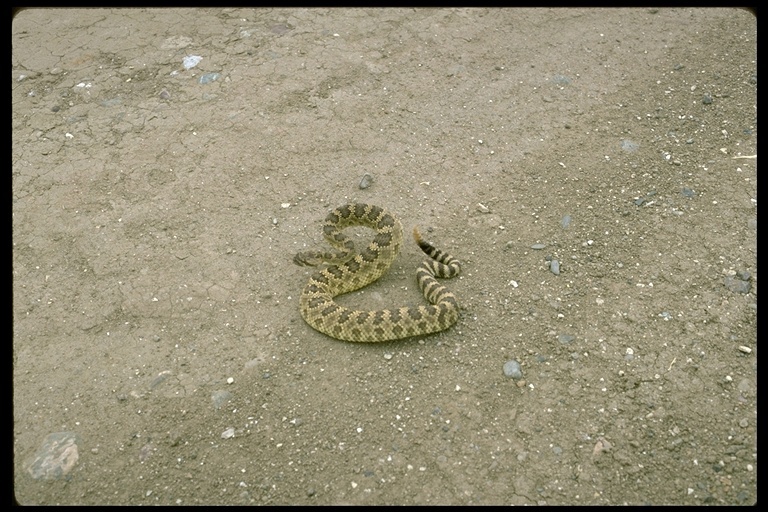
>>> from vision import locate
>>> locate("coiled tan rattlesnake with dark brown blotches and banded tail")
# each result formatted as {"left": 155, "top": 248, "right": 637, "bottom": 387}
{"left": 293, "top": 203, "right": 461, "bottom": 342}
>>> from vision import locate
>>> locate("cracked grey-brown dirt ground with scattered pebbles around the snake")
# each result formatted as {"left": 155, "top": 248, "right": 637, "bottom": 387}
{"left": 12, "top": 9, "right": 757, "bottom": 505}
